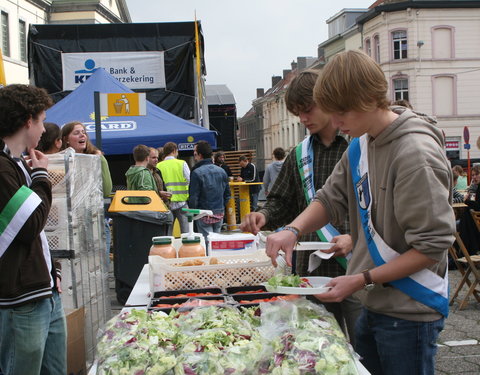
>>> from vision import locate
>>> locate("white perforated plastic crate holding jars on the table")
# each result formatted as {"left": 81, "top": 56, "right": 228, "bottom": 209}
{"left": 149, "top": 250, "right": 275, "bottom": 293}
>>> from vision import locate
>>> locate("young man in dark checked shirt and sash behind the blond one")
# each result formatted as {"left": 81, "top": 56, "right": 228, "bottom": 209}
{"left": 241, "top": 70, "right": 361, "bottom": 343}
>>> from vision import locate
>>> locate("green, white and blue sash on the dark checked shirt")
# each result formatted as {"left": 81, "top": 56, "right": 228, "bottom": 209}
{"left": 295, "top": 136, "right": 347, "bottom": 269}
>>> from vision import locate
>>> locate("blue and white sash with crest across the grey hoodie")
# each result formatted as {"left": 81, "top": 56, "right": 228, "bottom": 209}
{"left": 348, "top": 135, "right": 448, "bottom": 317}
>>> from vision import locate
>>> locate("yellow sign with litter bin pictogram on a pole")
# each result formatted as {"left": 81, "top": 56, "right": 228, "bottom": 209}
{"left": 100, "top": 92, "right": 147, "bottom": 117}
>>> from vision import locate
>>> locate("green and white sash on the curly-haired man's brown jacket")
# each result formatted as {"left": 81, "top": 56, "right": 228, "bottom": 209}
{"left": 0, "top": 185, "right": 42, "bottom": 258}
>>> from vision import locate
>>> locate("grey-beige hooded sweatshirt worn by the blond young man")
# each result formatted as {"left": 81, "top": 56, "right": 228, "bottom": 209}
{"left": 315, "top": 107, "right": 455, "bottom": 321}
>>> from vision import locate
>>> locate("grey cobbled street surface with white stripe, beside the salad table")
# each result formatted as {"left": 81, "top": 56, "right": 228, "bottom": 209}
{"left": 110, "top": 271, "right": 480, "bottom": 375}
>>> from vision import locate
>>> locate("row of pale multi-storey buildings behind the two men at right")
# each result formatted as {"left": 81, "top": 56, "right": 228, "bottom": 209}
{"left": 240, "top": 0, "right": 480, "bottom": 168}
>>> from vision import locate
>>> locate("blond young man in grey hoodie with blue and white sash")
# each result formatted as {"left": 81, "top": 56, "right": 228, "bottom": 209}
{"left": 267, "top": 51, "right": 455, "bottom": 375}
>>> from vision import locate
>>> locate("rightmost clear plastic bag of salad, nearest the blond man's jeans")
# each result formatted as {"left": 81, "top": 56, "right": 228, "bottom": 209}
{"left": 259, "top": 298, "right": 358, "bottom": 375}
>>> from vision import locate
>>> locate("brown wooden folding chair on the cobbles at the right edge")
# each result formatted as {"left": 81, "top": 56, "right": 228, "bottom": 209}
{"left": 448, "top": 232, "right": 480, "bottom": 310}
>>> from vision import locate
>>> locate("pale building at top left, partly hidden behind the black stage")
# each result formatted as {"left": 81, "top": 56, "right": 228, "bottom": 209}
{"left": 0, "top": 0, "right": 131, "bottom": 84}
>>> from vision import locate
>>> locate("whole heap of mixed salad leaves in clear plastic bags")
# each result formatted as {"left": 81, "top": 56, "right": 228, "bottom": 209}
{"left": 97, "top": 298, "right": 357, "bottom": 375}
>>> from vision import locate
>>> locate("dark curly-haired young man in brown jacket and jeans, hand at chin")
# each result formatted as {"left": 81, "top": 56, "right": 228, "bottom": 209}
{"left": 0, "top": 85, "right": 67, "bottom": 375}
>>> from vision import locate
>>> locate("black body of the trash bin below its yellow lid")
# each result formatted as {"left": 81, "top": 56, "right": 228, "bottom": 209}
{"left": 109, "top": 211, "right": 173, "bottom": 305}
